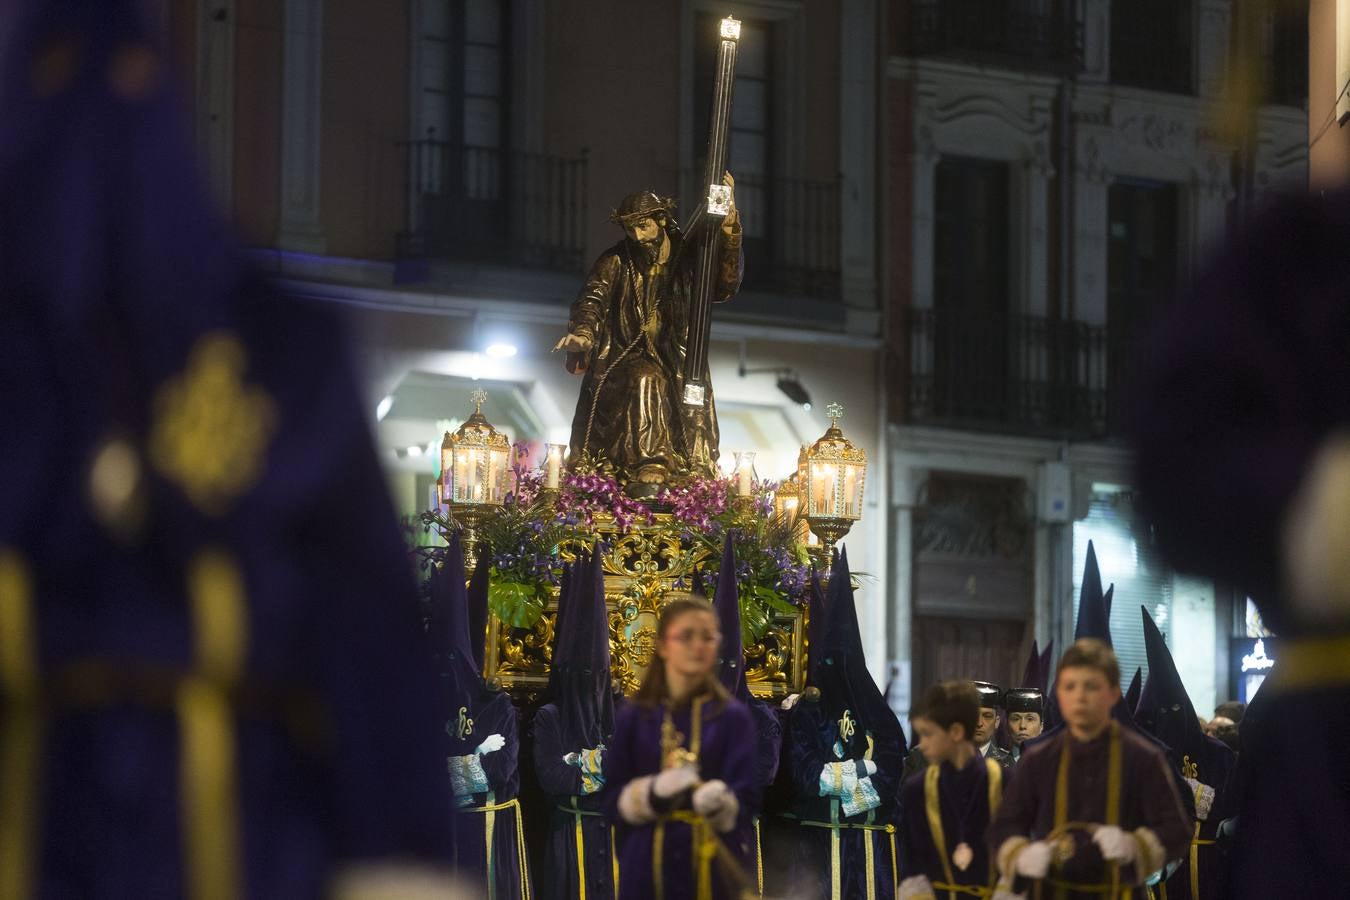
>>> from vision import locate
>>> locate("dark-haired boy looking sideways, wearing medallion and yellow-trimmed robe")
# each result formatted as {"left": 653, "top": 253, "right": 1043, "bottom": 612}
{"left": 899, "top": 681, "right": 1004, "bottom": 900}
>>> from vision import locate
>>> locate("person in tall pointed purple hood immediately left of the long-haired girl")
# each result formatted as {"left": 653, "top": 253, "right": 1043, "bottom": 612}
{"left": 535, "top": 548, "right": 617, "bottom": 900}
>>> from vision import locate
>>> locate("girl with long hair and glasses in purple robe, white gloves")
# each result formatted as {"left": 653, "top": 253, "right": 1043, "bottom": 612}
{"left": 606, "top": 596, "right": 760, "bottom": 900}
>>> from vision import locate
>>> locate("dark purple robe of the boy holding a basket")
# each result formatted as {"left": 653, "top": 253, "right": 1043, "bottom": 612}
{"left": 988, "top": 725, "right": 1192, "bottom": 899}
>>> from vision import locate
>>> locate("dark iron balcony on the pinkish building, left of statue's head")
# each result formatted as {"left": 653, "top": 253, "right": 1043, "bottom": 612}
{"left": 396, "top": 136, "right": 586, "bottom": 273}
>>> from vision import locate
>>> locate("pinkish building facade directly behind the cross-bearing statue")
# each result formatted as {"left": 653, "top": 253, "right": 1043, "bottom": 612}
{"left": 149, "top": 0, "right": 890, "bottom": 675}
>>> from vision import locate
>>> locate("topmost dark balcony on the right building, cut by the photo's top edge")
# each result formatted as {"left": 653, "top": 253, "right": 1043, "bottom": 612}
{"left": 895, "top": 0, "right": 1083, "bottom": 72}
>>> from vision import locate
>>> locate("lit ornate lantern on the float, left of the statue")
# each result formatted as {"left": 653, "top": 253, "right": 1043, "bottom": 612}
{"left": 440, "top": 390, "right": 510, "bottom": 564}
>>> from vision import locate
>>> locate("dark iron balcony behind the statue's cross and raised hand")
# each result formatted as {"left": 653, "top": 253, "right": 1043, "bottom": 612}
{"left": 680, "top": 170, "right": 840, "bottom": 301}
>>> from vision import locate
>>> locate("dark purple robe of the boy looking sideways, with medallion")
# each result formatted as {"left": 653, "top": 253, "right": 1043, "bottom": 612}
{"left": 899, "top": 753, "right": 1011, "bottom": 900}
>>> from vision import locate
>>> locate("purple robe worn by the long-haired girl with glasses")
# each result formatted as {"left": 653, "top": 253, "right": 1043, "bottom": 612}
{"left": 605, "top": 699, "right": 760, "bottom": 900}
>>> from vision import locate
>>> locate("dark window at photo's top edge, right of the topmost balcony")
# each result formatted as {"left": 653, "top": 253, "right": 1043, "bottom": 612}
{"left": 1111, "top": 0, "right": 1195, "bottom": 93}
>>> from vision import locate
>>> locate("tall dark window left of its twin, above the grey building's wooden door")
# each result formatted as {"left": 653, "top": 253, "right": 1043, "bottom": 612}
{"left": 933, "top": 158, "right": 1013, "bottom": 421}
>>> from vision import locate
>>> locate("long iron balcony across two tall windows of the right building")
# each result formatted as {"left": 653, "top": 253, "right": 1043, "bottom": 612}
{"left": 906, "top": 309, "right": 1114, "bottom": 439}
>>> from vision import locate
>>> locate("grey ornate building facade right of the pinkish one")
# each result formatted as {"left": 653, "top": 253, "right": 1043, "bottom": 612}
{"left": 882, "top": 0, "right": 1308, "bottom": 711}
